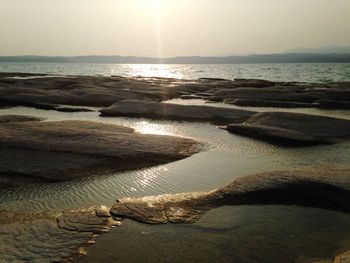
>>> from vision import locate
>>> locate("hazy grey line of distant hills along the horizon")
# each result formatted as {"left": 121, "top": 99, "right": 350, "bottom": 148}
{"left": 0, "top": 51, "right": 350, "bottom": 64}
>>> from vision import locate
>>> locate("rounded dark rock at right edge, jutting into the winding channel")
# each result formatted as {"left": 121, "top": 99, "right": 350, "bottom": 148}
{"left": 227, "top": 112, "right": 350, "bottom": 146}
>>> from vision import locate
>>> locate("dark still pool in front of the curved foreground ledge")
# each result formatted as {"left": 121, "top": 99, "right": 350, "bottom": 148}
{"left": 81, "top": 206, "right": 350, "bottom": 263}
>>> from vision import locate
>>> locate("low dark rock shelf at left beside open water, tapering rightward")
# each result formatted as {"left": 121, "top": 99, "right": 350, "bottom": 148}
{"left": 0, "top": 74, "right": 216, "bottom": 109}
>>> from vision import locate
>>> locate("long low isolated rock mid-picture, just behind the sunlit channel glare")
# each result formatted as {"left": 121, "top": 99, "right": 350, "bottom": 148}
{"left": 100, "top": 100, "right": 255, "bottom": 123}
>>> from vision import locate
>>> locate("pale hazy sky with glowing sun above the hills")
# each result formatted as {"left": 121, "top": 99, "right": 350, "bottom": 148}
{"left": 0, "top": 0, "right": 350, "bottom": 57}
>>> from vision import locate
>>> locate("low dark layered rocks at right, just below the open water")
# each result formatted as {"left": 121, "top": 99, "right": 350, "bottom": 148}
{"left": 209, "top": 80, "right": 350, "bottom": 109}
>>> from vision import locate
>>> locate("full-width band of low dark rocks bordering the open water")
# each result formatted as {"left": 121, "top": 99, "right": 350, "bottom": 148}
{"left": 0, "top": 73, "right": 350, "bottom": 110}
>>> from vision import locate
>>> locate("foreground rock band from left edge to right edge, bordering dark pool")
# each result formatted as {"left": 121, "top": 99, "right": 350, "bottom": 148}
{"left": 0, "top": 169, "right": 350, "bottom": 262}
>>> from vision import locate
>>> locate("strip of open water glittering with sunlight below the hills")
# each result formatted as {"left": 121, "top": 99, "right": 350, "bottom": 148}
{"left": 0, "top": 62, "right": 350, "bottom": 82}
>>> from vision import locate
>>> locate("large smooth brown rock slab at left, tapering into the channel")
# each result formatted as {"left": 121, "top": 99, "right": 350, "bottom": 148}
{"left": 0, "top": 118, "right": 201, "bottom": 186}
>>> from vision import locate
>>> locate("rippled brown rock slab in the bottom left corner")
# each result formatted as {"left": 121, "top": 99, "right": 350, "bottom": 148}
{"left": 0, "top": 207, "right": 120, "bottom": 262}
